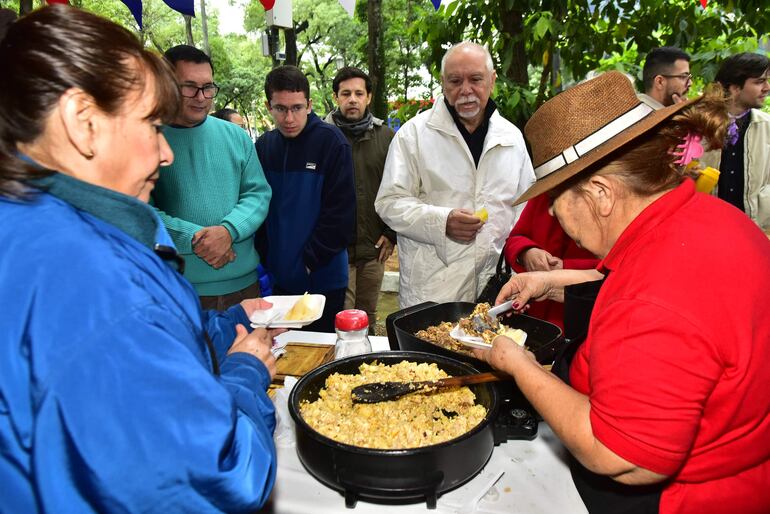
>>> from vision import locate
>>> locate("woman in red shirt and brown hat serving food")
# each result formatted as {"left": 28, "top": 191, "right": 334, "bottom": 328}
{"left": 477, "top": 72, "right": 770, "bottom": 514}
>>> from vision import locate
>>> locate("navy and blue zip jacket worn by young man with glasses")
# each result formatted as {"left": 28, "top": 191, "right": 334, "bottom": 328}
{"left": 256, "top": 112, "right": 356, "bottom": 294}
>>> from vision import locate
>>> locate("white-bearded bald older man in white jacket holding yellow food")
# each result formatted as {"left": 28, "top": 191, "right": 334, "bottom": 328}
{"left": 374, "top": 41, "right": 535, "bottom": 308}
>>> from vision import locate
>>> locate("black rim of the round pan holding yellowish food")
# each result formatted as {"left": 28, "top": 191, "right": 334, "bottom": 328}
{"left": 289, "top": 350, "right": 500, "bottom": 457}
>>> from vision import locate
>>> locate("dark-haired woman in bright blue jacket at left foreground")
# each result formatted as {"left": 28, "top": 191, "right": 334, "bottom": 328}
{"left": 0, "top": 5, "right": 282, "bottom": 512}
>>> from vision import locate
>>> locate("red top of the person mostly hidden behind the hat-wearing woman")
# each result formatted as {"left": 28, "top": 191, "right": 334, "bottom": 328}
{"left": 503, "top": 195, "right": 599, "bottom": 328}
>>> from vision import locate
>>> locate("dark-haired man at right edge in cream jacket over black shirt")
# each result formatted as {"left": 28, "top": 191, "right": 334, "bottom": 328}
{"left": 701, "top": 52, "right": 770, "bottom": 231}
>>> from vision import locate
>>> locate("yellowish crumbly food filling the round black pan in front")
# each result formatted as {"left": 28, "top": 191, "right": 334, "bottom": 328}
{"left": 300, "top": 361, "right": 487, "bottom": 449}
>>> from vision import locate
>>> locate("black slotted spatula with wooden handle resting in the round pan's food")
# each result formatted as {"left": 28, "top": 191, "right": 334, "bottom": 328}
{"left": 350, "top": 371, "right": 511, "bottom": 403}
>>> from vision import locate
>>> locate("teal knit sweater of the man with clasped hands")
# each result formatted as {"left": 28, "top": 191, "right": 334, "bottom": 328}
{"left": 152, "top": 116, "right": 271, "bottom": 296}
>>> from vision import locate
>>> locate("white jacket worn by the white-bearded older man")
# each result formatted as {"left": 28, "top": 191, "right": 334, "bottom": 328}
{"left": 374, "top": 97, "right": 535, "bottom": 308}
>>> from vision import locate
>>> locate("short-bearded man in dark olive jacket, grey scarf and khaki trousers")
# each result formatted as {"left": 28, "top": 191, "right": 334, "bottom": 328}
{"left": 325, "top": 67, "right": 396, "bottom": 334}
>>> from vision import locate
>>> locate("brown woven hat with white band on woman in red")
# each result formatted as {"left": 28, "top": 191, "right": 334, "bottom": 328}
{"left": 514, "top": 71, "right": 698, "bottom": 205}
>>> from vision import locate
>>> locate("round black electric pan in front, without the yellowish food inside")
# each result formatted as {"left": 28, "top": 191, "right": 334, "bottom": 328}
{"left": 289, "top": 352, "right": 498, "bottom": 509}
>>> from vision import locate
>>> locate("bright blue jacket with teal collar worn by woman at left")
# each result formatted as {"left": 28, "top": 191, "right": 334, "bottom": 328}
{"left": 0, "top": 175, "right": 276, "bottom": 513}
